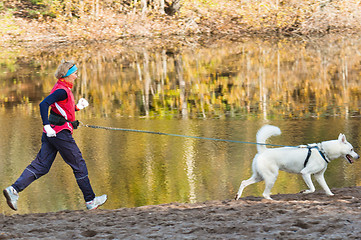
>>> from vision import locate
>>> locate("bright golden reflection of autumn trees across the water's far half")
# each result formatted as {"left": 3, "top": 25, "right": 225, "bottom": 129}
{"left": 0, "top": 37, "right": 361, "bottom": 119}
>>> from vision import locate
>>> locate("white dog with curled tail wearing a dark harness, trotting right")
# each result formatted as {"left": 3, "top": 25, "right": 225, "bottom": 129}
{"left": 236, "top": 125, "right": 359, "bottom": 200}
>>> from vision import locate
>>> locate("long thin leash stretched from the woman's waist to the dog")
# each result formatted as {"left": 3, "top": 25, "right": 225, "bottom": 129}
{"left": 80, "top": 122, "right": 299, "bottom": 147}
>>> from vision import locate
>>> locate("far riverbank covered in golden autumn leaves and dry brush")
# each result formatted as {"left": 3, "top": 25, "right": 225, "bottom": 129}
{"left": 0, "top": 0, "right": 361, "bottom": 48}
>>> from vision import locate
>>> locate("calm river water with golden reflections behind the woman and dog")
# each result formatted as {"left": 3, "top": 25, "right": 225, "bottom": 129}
{"left": 0, "top": 36, "right": 361, "bottom": 214}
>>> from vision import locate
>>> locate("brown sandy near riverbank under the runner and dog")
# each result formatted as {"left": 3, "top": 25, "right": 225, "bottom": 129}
{"left": 0, "top": 187, "right": 361, "bottom": 239}
